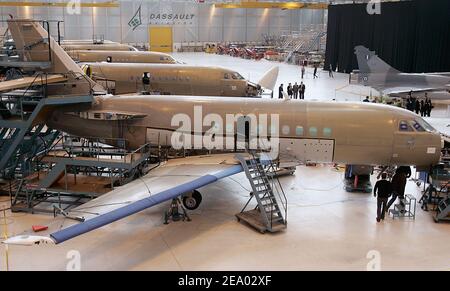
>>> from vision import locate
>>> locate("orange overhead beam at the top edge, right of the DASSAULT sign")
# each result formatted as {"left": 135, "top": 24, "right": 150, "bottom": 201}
{"left": 214, "top": 1, "right": 328, "bottom": 10}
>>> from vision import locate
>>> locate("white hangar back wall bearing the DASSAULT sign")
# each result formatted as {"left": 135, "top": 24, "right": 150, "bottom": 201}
{"left": 0, "top": 0, "right": 326, "bottom": 43}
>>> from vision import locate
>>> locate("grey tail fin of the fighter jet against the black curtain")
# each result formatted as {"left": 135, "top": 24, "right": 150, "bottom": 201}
{"left": 355, "top": 45, "right": 399, "bottom": 74}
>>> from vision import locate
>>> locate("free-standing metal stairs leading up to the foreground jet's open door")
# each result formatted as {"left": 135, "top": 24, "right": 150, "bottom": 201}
{"left": 236, "top": 152, "right": 287, "bottom": 233}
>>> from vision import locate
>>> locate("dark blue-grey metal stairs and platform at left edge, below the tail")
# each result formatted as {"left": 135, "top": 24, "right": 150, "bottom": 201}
{"left": 0, "top": 75, "right": 93, "bottom": 179}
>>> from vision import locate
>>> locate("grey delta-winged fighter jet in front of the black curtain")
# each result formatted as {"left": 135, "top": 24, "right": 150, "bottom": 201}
{"left": 355, "top": 46, "right": 450, "bottom": 98}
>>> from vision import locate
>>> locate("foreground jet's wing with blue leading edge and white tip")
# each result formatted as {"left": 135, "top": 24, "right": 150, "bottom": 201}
{"left": 3, "top": 154, "right": 242, "bottom": 246}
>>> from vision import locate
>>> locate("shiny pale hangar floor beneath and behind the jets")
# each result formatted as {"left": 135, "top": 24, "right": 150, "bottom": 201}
{"left": 0, "top": 54, "right": 450, "bottom": 270}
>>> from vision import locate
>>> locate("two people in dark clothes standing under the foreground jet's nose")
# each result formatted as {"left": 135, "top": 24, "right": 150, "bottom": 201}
{"left": 373, "top": 167, "right": 411, "bottom": 222}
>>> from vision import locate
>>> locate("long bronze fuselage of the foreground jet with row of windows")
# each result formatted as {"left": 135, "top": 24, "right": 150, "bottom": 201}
{"left": 49, "top": 96, "right": 441, "bottom": 167}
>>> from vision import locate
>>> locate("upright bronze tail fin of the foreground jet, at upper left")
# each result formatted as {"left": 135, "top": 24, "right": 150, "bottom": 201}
{"left": 8, "top": 19, "right": 102, "bottom": 91}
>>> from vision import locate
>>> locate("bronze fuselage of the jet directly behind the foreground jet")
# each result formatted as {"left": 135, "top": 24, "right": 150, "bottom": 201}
{"left": 83, "top": 63, "right": 261, "bottom": 97}
